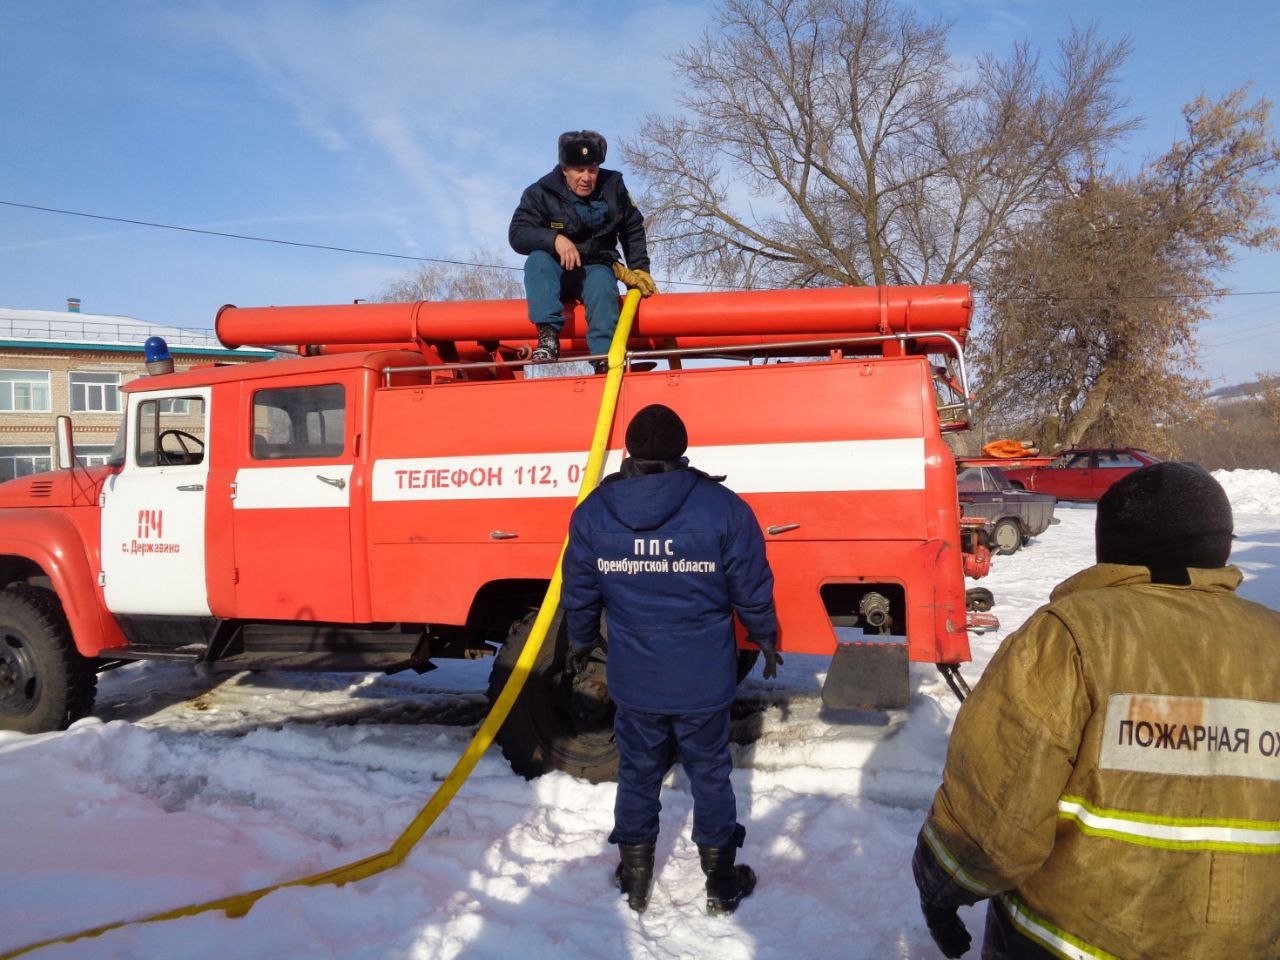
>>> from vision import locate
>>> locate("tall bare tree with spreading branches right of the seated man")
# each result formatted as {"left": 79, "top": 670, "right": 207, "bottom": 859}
{"left": 623, "top": 0, "right": 1133, "bottom": 287}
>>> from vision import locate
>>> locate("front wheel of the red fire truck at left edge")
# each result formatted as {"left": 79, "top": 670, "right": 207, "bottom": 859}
{"left": 0, "top": 586, "right": 97, "bottom": 733}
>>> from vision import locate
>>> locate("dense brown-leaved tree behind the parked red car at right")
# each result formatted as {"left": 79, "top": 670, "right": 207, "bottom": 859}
{"left": 977, "top": 90, "right": 1280, "bottom": 452}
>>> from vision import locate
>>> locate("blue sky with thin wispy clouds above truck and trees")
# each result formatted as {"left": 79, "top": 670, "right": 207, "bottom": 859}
{"left": 0, "top": 0, "right": 1280, "bottom": 383}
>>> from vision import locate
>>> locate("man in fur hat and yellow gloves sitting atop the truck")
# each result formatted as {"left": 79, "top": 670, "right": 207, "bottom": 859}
{"left": 507, "top": 131, "right": 658, "bottom": 372}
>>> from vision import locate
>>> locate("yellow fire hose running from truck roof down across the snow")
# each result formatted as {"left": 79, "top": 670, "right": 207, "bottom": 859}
{"left": 0, "top": 291, "right": 640, "bottom": 960}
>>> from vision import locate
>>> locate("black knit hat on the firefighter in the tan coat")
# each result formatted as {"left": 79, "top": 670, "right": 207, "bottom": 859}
{"left": 1094, "top": 461, "right": 1231, "bottom": 582}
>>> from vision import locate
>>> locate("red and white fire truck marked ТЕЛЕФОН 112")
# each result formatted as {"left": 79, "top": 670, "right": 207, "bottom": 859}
{"left": 0, "top": 287, "right": 970, "bottom": 777}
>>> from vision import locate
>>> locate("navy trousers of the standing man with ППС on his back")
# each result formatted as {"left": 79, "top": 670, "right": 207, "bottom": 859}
{"left": 609, "top": 707, "right": 745, "bottom": 847}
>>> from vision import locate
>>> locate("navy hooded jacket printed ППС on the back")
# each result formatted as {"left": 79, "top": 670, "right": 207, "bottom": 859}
{"left": 562, "top": 468, "right": 778, "bottom": 714}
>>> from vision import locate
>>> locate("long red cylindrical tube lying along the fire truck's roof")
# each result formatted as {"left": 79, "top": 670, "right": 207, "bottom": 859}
{"left": 215, "top": 284, "right": 973, "bottom": 347}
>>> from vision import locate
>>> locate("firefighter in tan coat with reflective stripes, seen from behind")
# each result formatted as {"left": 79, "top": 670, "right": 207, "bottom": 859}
{"left": 911, "top": 462, "right": 1280, "bottom": 960}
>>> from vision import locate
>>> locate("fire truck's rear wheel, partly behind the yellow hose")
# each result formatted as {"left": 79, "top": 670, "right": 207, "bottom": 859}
{"left": 489, "top": 611, "right": 618, "bottom": 783}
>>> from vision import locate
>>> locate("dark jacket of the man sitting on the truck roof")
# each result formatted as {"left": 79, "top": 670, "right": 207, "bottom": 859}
{"left": 507, "top": 166, "right": 649, "bottom": 270}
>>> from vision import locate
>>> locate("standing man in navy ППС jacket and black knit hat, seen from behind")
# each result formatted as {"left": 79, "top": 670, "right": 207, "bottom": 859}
{"left": 562, "top": 403, "right": 782, "bottom": 914}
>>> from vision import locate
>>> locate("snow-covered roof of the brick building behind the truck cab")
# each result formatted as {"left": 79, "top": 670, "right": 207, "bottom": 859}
{"left": 0, "top": 307, "right": 275, "bottom": 358}
